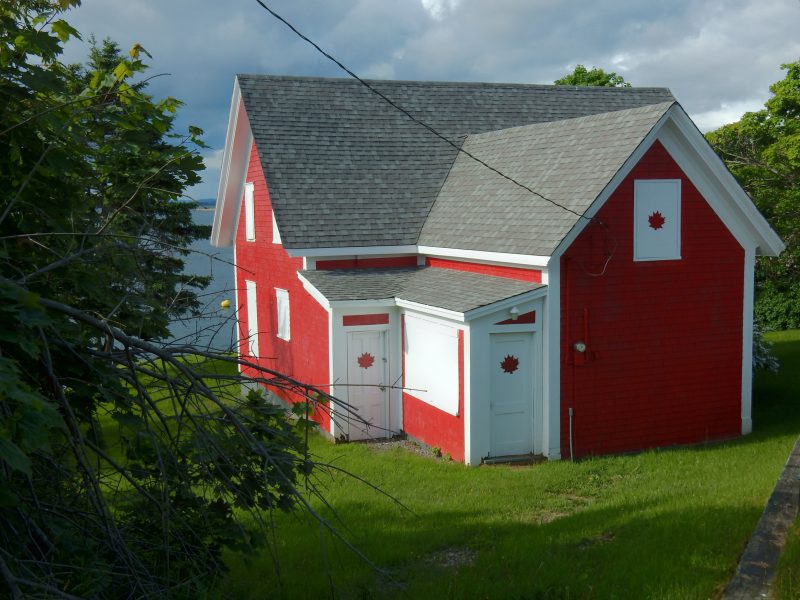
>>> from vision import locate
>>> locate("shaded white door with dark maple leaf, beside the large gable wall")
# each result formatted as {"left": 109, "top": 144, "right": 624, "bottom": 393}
{"left": 490, "top": 333, "right": 533, "bottom": 456}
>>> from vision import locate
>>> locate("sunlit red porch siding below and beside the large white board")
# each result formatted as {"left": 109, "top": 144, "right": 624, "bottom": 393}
{"left": 401, "top": 318, "right": 464, "bottom": 462}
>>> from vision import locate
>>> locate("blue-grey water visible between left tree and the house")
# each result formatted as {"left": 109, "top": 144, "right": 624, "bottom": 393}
{"left": 170, "top": 209, "right": 236, "bottom": 351}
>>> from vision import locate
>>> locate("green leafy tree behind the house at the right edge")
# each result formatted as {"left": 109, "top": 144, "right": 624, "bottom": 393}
{"left": 706, "top": 61, "right": 800, "bottom": 329}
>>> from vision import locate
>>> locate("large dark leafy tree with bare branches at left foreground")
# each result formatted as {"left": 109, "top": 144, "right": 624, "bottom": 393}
{"left": 0, "top": 0, "right": 366, "bottom": 598}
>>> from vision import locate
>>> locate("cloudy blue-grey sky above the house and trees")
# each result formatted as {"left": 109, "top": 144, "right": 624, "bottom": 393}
{"left": 61, "top": 0, "right": 800, "bottom": 198}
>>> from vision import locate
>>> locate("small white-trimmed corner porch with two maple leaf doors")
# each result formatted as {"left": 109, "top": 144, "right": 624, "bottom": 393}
{"left": 298, "top": 267, "right": 547, "bottom": 464}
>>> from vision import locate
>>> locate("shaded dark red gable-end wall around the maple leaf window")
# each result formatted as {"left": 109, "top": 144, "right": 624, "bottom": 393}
{"left": 561, "top": 142, "right": 744, "bottom": 456}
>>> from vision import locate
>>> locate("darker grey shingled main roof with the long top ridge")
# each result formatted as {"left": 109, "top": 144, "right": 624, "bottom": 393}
{"left": 238, "top": 75, "right": 673, "bottom": 249}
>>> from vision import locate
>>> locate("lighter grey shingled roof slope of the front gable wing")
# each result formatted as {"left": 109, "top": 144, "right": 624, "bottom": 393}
{"left": 419, "top": 102, "right": 673, "bottom": 256}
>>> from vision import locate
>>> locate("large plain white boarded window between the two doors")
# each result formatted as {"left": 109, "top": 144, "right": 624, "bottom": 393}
{"left": 403, "top": 314, "right": 458, "bottom": 415}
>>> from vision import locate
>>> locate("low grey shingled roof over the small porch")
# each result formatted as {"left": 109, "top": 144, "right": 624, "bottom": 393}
{"left": 300, "top": 267, "right": 545, "bottom": 313}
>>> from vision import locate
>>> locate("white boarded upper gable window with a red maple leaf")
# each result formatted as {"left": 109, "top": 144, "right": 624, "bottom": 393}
{"left": 633, "top": 179, "right": 681, "bottom": 261}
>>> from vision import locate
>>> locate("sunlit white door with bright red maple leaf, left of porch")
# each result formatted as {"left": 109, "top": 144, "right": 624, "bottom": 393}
{"left": 340, "top": 331, "right": 389, "bottom": 440}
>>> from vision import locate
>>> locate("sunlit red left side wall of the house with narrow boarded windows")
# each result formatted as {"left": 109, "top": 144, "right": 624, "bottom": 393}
{"left": 235, "top": 144, "right": 330, "bottom": 431}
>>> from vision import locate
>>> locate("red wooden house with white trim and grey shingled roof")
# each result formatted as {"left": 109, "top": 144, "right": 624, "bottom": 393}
{"left": 212, "top": 75, "right": 783, "bottom": 465}
